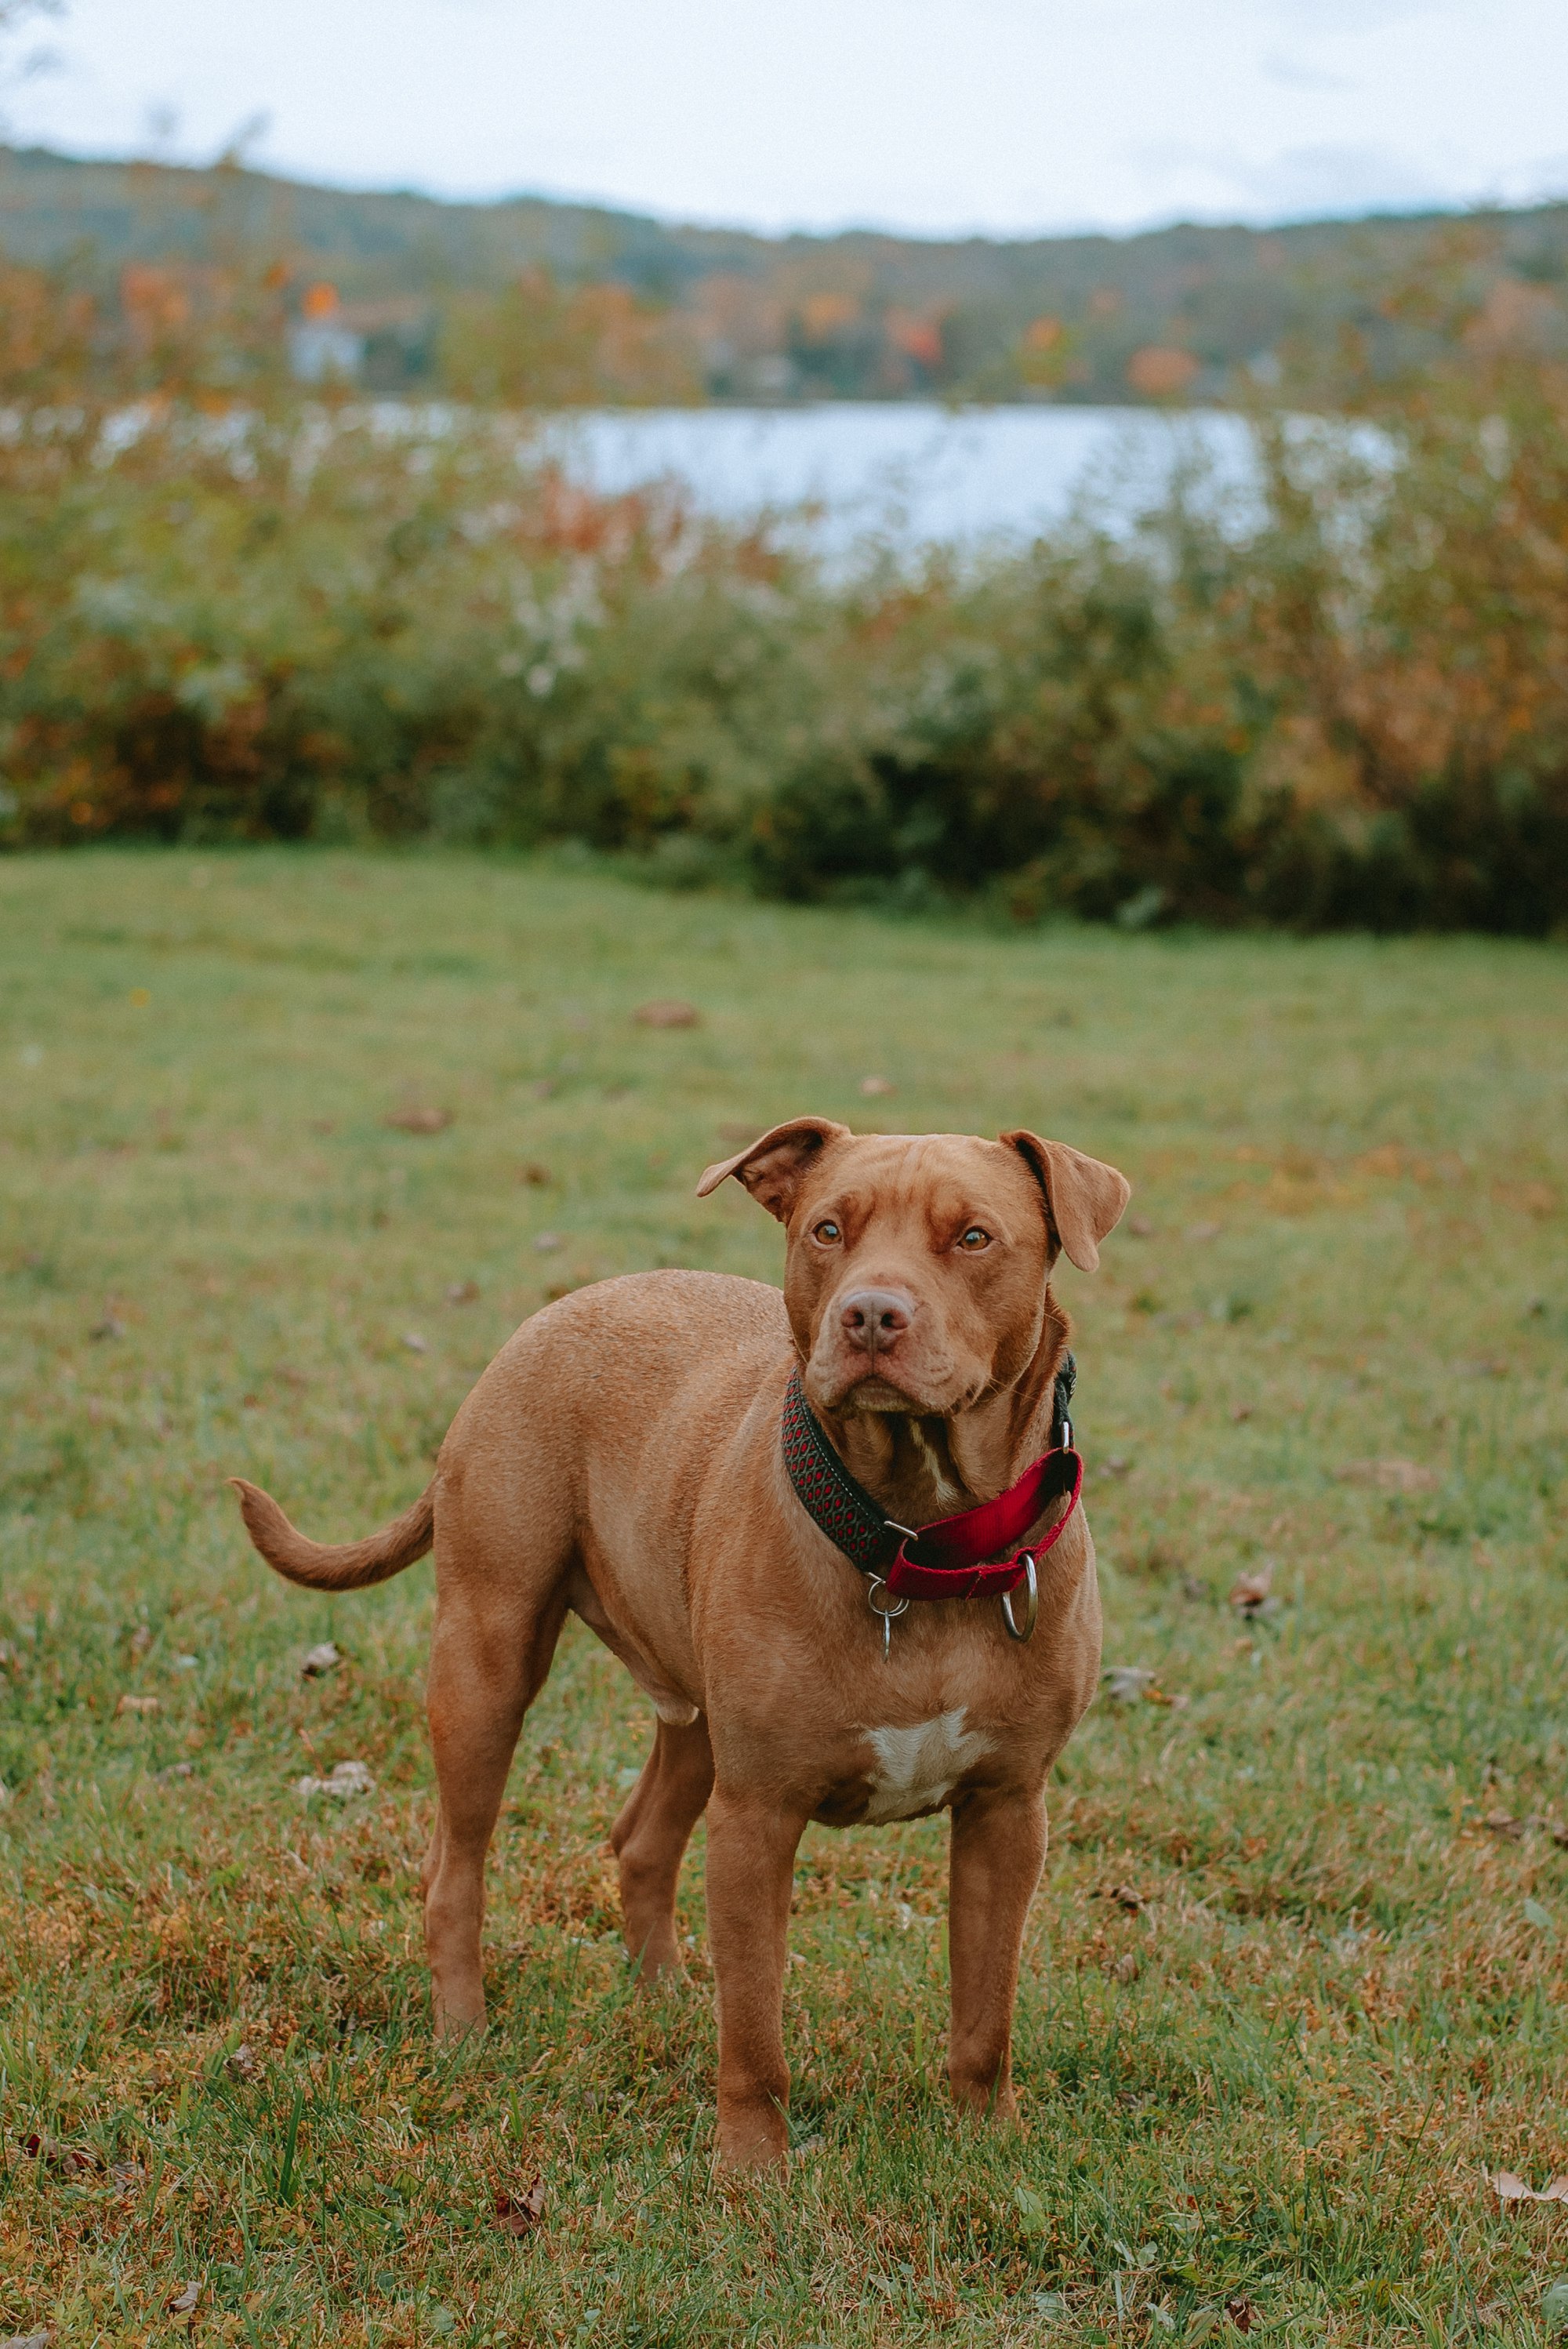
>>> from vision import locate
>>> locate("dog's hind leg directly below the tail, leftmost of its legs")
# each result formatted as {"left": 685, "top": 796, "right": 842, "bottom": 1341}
{"left": 423, "top": 1583, "right": 566, "bottom": 2039}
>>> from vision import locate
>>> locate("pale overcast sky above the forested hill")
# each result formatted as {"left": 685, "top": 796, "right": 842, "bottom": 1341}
{"left": 5, "top": 0, "right": 1568, "bottom": 233}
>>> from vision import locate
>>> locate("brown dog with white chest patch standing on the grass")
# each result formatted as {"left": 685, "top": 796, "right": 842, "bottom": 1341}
{"left": 234, "top": 1118, "right": 1129, "bottom": 2163}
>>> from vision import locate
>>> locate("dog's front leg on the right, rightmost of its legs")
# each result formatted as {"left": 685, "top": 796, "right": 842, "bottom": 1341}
{"left": 949, "top": 1792, "right": 1044, "bottom": 2116}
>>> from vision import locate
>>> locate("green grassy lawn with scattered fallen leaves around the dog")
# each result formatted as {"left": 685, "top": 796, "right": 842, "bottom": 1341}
{"left": 0, "top": 851, "right": 1568, "bottom": 2349}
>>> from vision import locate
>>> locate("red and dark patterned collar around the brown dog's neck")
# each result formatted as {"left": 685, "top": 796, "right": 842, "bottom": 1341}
{"left": 784, "top": 1370, "right": 1084, "bottom": 1611}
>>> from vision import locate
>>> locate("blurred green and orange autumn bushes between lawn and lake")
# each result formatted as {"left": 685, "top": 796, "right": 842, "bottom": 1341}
{"left": 0, "top": 248, "right": 1568, "bottom": 932}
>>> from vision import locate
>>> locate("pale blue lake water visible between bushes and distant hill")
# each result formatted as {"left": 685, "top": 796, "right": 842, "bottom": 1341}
{"left": 545, "top": 401, "right": 1251, "bottom": 552}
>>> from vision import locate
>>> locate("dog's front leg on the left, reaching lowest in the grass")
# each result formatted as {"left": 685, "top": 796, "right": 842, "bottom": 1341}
{"left": 706, "top": 1788, "right": 805, "bottom": 2168}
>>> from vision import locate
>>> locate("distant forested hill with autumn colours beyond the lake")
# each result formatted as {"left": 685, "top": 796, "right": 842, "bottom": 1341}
{"left": 0, "top": 148, "right": 1568, "bottom": 401}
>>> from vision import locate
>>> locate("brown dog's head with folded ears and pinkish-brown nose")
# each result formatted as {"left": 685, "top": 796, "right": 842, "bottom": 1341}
{"left": 697, "top": 1118, "right": 1131, "bottom": 1419}
